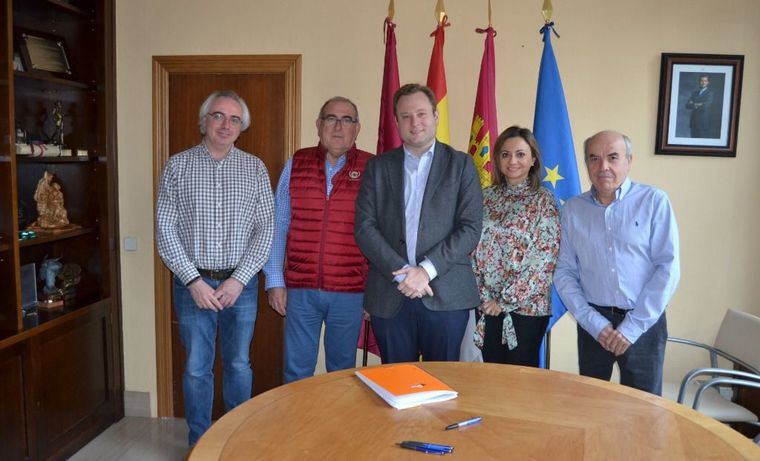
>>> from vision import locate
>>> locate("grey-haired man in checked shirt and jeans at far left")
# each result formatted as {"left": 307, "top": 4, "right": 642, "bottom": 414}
{"left": 156, "top": 91, "right": 274, "bottom": 446}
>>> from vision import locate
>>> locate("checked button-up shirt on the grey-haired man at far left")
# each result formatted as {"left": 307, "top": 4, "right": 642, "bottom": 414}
{"left": 156, "top": 143, "right": 274, "bottom": 285}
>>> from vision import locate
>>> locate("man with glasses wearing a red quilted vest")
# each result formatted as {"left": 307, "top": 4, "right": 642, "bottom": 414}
{"left": 264, "top": 96, "right": 372, "bottom": 382}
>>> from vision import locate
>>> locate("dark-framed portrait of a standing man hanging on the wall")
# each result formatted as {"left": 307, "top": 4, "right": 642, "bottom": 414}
{"left": 655, "top": 53, "right": 744, "bottom": 157}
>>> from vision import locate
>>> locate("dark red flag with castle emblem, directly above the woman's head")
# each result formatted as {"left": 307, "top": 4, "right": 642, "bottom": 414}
{"left": 469, "top": 26, "right": 499, "bottom": 187}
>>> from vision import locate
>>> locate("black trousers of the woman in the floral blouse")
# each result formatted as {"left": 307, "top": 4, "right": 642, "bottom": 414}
{"left": 476, "top": 311, "right": 550, "bottom": 368}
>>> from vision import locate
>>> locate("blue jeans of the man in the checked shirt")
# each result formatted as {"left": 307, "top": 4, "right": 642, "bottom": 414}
{"left": 173, "top": 276, "right": 259, "bottom": 446}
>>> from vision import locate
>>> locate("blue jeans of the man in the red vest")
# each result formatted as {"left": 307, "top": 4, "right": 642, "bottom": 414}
{"left": 283, "top": 288, "right": 364, "bottom": 383}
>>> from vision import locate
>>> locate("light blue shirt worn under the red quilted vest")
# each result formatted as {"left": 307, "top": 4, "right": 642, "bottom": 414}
{"left": 264, "top": 154, "right": 346, "bottom": 290}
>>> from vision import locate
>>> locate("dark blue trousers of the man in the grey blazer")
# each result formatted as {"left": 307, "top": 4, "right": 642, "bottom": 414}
{"left": 372, "top": 298, "right": 470, "bottom": 363}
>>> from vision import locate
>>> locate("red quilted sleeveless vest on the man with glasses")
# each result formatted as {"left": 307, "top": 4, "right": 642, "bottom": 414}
{"left": 285, "top": 145, "right": 372, "bottom": 293}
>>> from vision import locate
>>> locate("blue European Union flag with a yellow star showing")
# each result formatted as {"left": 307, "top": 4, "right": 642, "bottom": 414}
{"left": 533, "top": 22, "right": 581, "bottom": 368}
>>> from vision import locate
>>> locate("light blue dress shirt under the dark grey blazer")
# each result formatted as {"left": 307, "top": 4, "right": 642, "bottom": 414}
{"left": 395, "top": 140, "right": 438, "bottom": 282}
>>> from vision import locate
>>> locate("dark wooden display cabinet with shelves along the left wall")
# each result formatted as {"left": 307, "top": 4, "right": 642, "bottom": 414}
{"left": 0, "top": 0, "right": 124, "bottom": 460}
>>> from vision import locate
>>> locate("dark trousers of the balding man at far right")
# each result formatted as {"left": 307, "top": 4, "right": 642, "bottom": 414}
{"left": 578, "top": 307, "right": 668, "bottom": 395}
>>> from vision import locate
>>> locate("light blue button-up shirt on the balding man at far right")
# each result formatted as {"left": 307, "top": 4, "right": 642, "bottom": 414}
{"left": 554, "top": 178, "right": 680, "bottom": 343}
